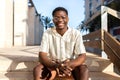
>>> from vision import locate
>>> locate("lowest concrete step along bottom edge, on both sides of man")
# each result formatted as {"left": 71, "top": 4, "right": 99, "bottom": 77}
{"left": 0, "top": 72, "right": 120, "bottom": 80}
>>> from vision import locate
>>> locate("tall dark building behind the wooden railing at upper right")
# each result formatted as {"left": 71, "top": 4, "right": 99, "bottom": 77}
{"left": 84, "top": 0, "right": 120, "bottom": 40}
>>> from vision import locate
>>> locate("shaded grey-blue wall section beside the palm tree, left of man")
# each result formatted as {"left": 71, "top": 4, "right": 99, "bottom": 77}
{"left": 27, "top": 7, "right": 43, "bottom": 45}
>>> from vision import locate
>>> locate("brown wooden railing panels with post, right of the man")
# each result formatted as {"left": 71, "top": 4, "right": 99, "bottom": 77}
{"left": 83, "top": 30, "right": 120, "bottom": 68}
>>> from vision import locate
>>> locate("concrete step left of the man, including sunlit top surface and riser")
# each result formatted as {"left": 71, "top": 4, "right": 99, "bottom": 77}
{"left": 0, "top": 46, "right": 39, "bottom": 72}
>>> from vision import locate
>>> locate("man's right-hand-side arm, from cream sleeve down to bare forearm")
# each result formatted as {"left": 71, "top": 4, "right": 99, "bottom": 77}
{"left": 66, "top": 32, "right": 86, "bottom": 68}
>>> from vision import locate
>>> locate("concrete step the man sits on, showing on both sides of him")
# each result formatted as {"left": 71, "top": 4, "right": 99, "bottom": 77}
{"left": 0, "top": 47, "right": 113, "bottom": 72}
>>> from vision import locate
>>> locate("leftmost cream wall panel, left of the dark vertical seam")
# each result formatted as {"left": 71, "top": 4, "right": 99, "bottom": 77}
{"left": 0, "top": 0, "right": 13, "bottom": 47}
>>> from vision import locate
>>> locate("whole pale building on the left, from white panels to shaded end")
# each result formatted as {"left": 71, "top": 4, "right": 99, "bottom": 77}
{"left": 0, "top": 0, "right": 43, "bottom": 48}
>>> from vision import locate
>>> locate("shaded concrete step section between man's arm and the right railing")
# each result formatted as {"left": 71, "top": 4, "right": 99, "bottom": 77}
{"left": 86, "top": 53, "right": 114, "bottom": 72}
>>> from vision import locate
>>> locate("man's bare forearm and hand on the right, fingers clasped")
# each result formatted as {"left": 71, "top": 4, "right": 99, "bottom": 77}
{"left": 55, "top": 53, "right": 86, "bottom": 76}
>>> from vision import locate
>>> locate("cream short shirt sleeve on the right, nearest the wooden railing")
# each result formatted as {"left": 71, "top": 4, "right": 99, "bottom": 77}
{"left": 74, "top": 33, "right": 86, "bottom": 56}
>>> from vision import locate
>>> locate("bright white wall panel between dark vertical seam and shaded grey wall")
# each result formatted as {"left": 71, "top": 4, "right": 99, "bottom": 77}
{"left": 14, "top": 0, "right": 28, "bottom": 46}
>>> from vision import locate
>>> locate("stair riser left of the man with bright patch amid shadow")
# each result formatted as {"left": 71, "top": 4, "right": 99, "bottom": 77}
{"left": 0, "top": 61, "right": 37, "bottom": 72}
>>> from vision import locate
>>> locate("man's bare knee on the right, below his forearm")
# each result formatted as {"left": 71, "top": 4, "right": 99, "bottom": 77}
{"left": 72, "top": 65, "right": 89, "bottom": 80}
